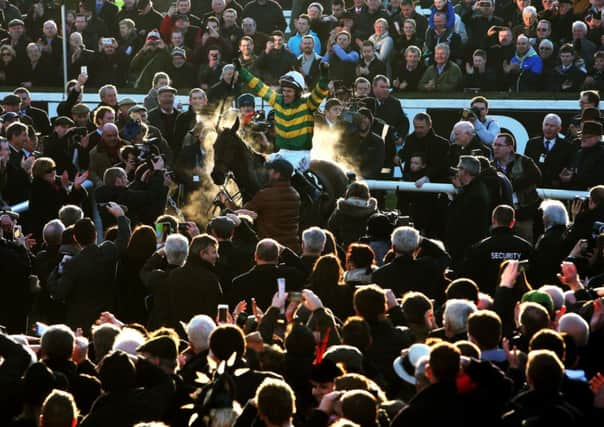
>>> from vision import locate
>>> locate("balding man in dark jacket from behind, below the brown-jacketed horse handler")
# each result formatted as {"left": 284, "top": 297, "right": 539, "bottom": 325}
{"left": 227, "top": 239, "right": 302, "bottom": 310}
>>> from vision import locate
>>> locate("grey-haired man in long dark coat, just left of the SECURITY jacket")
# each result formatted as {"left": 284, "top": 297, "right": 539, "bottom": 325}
{"left": 445, "top": 156, "right": 490, "bottom": 267}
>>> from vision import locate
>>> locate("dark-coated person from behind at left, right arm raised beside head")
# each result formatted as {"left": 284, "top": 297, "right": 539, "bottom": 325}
{"left": 49, "top": 202, "right": 130, "bottom": 330}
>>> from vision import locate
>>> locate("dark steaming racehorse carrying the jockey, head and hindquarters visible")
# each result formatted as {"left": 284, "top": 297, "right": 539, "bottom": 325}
{"left": 211, "top": 118, "right": 348, "bottom": 226}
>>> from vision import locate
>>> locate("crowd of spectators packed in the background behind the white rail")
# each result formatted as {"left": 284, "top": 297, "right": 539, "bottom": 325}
{"left": 0, "top": 0, "right": 604, "bottom": 93}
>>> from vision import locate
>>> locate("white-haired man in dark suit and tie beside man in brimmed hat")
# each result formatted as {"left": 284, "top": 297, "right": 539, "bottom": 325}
{"left": 524, "top": 113, "right": 575, "bottom": 188}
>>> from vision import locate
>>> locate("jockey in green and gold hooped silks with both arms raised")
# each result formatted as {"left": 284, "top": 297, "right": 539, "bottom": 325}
{"left": 235, "top": 61, "right": 328, "bottom": 172}
